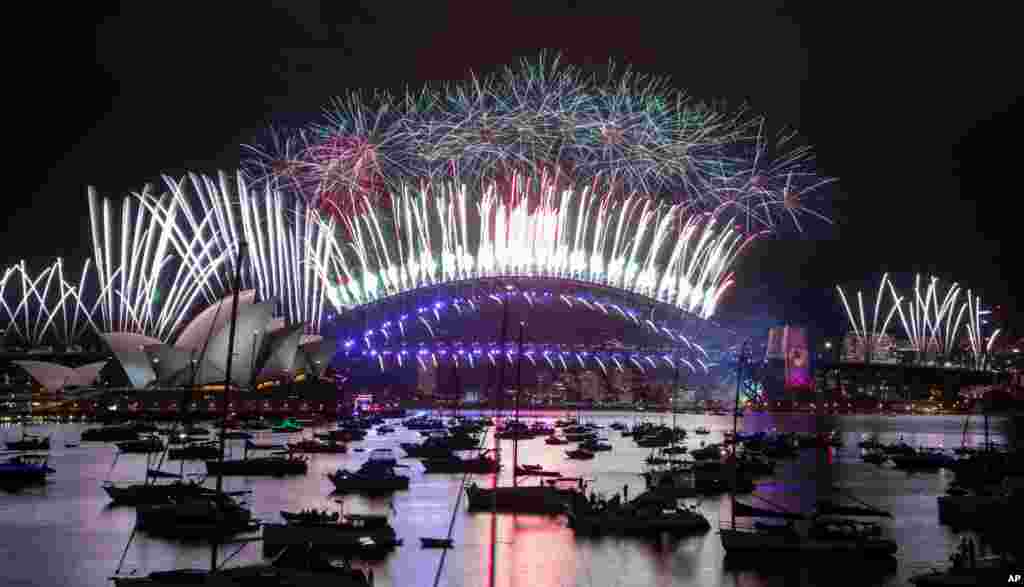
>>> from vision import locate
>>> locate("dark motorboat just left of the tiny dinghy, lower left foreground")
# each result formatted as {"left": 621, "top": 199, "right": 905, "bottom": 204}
{"left": 263, "top": 514, "right": 401, "bottom": 558}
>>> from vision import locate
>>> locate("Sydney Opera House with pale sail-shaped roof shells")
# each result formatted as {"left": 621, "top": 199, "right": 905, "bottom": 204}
{"left": 7, "top": 290, "right": 336, "bottom": 411}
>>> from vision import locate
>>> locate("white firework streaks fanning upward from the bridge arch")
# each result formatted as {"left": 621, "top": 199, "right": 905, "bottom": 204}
{"left": 327, "top": 172, "right": 762, "bottom": 322}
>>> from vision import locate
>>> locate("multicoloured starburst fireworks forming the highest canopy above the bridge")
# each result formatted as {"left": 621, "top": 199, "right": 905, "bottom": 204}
{"left": 247, "top": 56, "right": 833, "bottom": 230}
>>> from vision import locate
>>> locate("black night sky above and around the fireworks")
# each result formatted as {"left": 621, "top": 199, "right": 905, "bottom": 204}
{"left": 0, "top": 1, "right": 1024, "bottom": 338}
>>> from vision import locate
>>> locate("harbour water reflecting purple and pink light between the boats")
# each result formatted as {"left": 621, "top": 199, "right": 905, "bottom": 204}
{"left": 0, "top": 411, "right": 1017, "bottom": 587}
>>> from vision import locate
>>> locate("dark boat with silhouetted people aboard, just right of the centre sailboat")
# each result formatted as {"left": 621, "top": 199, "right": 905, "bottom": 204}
{"left": 567, "top": 493, "right": 711, "bottom": 536}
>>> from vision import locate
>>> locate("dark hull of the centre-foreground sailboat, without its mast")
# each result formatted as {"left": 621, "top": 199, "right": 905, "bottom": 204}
{"left": 466, "top": 477, "right": 586, "bottom": 513}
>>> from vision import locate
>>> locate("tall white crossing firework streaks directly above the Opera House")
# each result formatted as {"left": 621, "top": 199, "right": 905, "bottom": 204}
{"left": 90, "top": 174, "right": 340, "bottom": 340}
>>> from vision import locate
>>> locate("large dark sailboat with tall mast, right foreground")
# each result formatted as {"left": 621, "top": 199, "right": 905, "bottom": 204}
{"left": 719, "top": 344, "right": 898, "bottom": 558}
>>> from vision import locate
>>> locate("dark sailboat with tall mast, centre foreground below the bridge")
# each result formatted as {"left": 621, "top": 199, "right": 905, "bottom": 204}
{"left": 466, "top": 319, "right": 586, "bottom": 513}
